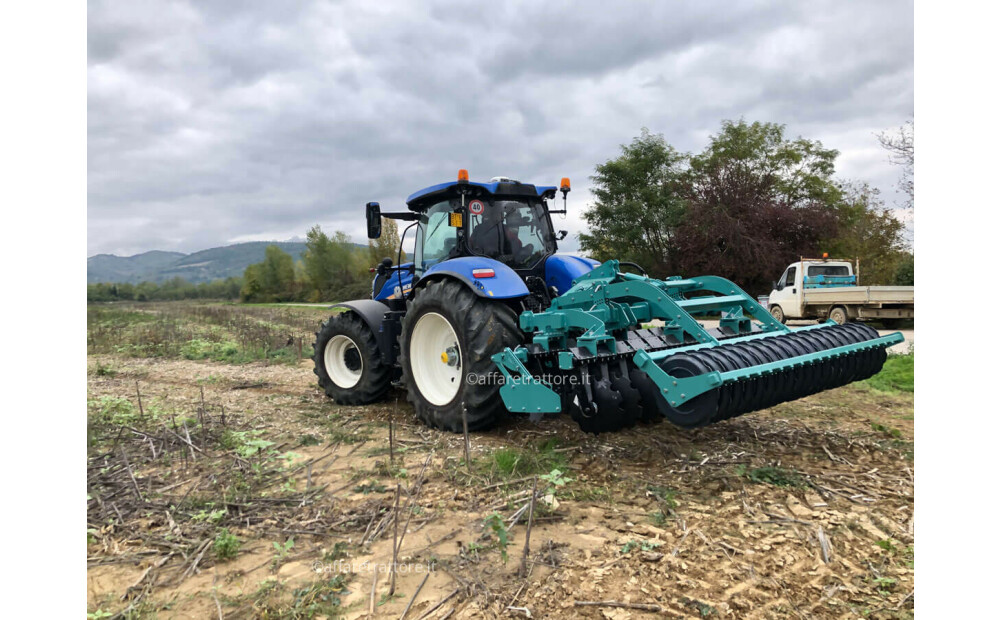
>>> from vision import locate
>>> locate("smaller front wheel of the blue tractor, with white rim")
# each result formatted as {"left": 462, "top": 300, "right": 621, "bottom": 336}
{"left": 313, "top": 312, "right": 392, "bottom": 405}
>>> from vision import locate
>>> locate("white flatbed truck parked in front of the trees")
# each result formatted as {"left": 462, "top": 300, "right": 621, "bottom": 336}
{"left": 759, "top": 258, "right": 913, "bottom": 329}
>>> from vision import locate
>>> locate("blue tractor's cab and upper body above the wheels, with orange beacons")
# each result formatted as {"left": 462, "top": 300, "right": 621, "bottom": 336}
{"left": 367, "top": 170, "right": 597, "bottom": 310}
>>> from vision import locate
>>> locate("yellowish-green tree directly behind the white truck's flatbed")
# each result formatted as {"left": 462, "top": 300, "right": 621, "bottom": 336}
{"left": 822, "top": 183, "right": 903, "bottom": 284}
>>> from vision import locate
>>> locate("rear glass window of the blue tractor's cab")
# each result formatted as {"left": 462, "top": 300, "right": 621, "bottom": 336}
{"left": 469, "top": 200, "right": 555, "bottom": 269}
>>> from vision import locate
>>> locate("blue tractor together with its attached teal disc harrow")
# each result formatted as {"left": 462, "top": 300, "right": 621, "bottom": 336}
{"left": 314, "top": 170, "right": 902, "bottom": 433}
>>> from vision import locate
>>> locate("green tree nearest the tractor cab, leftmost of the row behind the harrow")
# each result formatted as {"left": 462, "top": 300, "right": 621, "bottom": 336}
{"left": 580, "top": 128, "right": 686, "bottom": 276}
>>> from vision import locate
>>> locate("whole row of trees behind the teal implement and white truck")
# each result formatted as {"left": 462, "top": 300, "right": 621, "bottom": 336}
{"left": 580, "top": 120, "right": 913, "bottom": 294}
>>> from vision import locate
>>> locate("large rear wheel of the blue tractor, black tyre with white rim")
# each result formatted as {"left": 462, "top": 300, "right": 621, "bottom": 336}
{"left": 399, "top": 280, "right": 523, "bottom": 433}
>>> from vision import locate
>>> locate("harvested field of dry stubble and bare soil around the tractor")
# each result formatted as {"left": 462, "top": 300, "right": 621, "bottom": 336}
{"left": 87, "top": 302, "right": 914, "bottom": 619}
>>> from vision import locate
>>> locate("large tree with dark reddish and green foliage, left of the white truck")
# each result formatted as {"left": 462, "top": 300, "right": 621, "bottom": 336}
{"left": 672, "top": 119, "right": 842, "bottom": 293}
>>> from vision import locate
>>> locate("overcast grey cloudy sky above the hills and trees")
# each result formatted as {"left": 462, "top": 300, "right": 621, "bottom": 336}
{"left": 87, "top": 0, "right": 913, "bottom": 255}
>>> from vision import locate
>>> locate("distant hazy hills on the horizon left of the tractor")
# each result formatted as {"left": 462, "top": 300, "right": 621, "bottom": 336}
{"left": 87, "top": 241, "right": 312, "bottom": 284}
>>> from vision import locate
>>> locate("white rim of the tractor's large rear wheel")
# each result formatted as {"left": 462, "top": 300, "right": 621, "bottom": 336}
{"left": 409, "top": 312, "right": 462, "bottom": 407}
